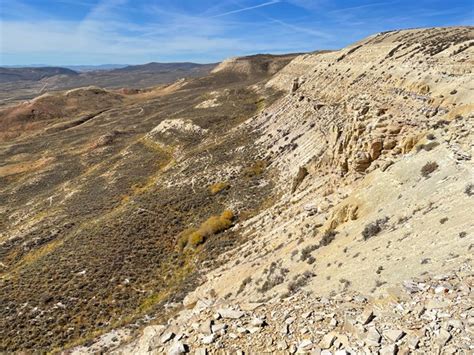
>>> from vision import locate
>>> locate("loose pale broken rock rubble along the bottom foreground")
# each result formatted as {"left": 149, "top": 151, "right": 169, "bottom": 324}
{"left": 115, "top": 264, "right": 474, "bottom": 355}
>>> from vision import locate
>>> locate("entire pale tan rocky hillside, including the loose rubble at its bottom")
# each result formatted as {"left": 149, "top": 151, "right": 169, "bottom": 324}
{"left": 105, "top": 28, "right": 474, "bottom": 354}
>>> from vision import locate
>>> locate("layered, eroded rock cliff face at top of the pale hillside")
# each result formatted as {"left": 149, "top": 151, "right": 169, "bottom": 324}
{"left": 262, "top": 28, "right": 474, "bottom": 184}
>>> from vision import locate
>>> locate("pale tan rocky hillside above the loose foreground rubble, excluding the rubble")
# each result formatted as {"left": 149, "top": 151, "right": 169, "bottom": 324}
{"left": 177, "top": 23, "right": 474, "bottom": 312}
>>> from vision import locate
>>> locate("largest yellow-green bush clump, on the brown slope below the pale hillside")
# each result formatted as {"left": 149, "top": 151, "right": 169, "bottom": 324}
{"left": 178, "top": 210, "right": 234, "bottom": 250}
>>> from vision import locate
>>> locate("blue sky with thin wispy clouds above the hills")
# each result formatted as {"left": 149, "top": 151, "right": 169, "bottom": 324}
{"left": 0, "top": 0, "right": 474, "bottom": 65}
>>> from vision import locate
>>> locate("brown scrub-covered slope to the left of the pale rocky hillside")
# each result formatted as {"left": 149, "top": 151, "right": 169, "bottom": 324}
{"left": 0, "top": 54, "right": 288, "bottom": 352}
